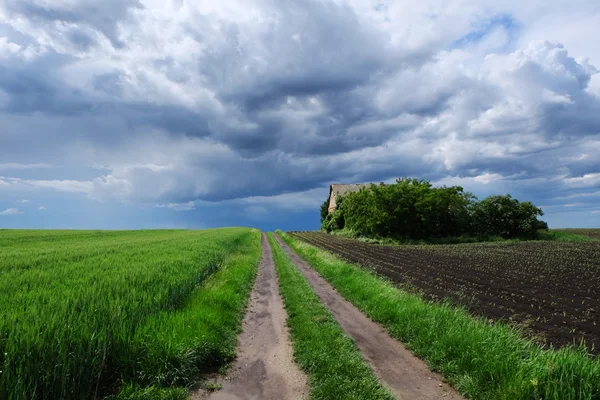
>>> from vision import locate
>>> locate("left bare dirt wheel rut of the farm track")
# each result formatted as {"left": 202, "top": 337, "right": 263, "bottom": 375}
{"left": 192, "top": 233, "right": 308, "bottom": 400}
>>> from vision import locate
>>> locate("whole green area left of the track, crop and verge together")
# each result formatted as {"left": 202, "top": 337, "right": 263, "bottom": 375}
{"left": 0, "top": 228, "right": 260, "bottom": 400}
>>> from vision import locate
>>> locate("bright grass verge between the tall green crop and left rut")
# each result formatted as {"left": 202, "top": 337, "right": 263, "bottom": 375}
{"left": 116, "top": 230, "right": 261, "bottom": 400}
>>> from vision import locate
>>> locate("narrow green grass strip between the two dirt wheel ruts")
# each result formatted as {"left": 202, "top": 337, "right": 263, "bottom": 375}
{"left": 269, "top": 234, "right": 393, "bottom": 400}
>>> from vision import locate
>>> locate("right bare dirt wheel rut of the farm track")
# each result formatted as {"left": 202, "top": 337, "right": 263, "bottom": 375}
{"left": 276, "top": 236, "right": 462, "bottom": 400}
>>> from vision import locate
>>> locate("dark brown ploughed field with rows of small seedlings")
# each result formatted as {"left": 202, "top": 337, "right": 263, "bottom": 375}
{"left": 293, "top": 230, "right": 600, "bottom": 353}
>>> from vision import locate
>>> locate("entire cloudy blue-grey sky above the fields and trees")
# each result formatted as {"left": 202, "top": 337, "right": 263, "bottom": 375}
{"left": 0, "top": 0, "right": 600, "bottom": 230}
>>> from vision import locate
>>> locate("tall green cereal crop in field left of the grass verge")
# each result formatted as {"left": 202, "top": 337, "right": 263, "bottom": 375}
{"left": 0, "top": 228, "right": 259, "bottom": 400}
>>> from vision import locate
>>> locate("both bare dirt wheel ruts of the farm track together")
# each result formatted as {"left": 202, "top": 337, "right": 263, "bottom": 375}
{"left": 192, "top": 233, "right": 463, "bottom": 400}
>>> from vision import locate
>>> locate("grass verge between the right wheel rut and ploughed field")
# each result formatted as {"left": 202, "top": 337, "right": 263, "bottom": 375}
{"left": 278, "top": 231, "right": 600, "bottom": 400}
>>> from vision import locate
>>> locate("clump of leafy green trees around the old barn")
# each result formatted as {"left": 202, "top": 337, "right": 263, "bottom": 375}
{"left": 321, "top": 178, "right": 548, "bottom": 240}
